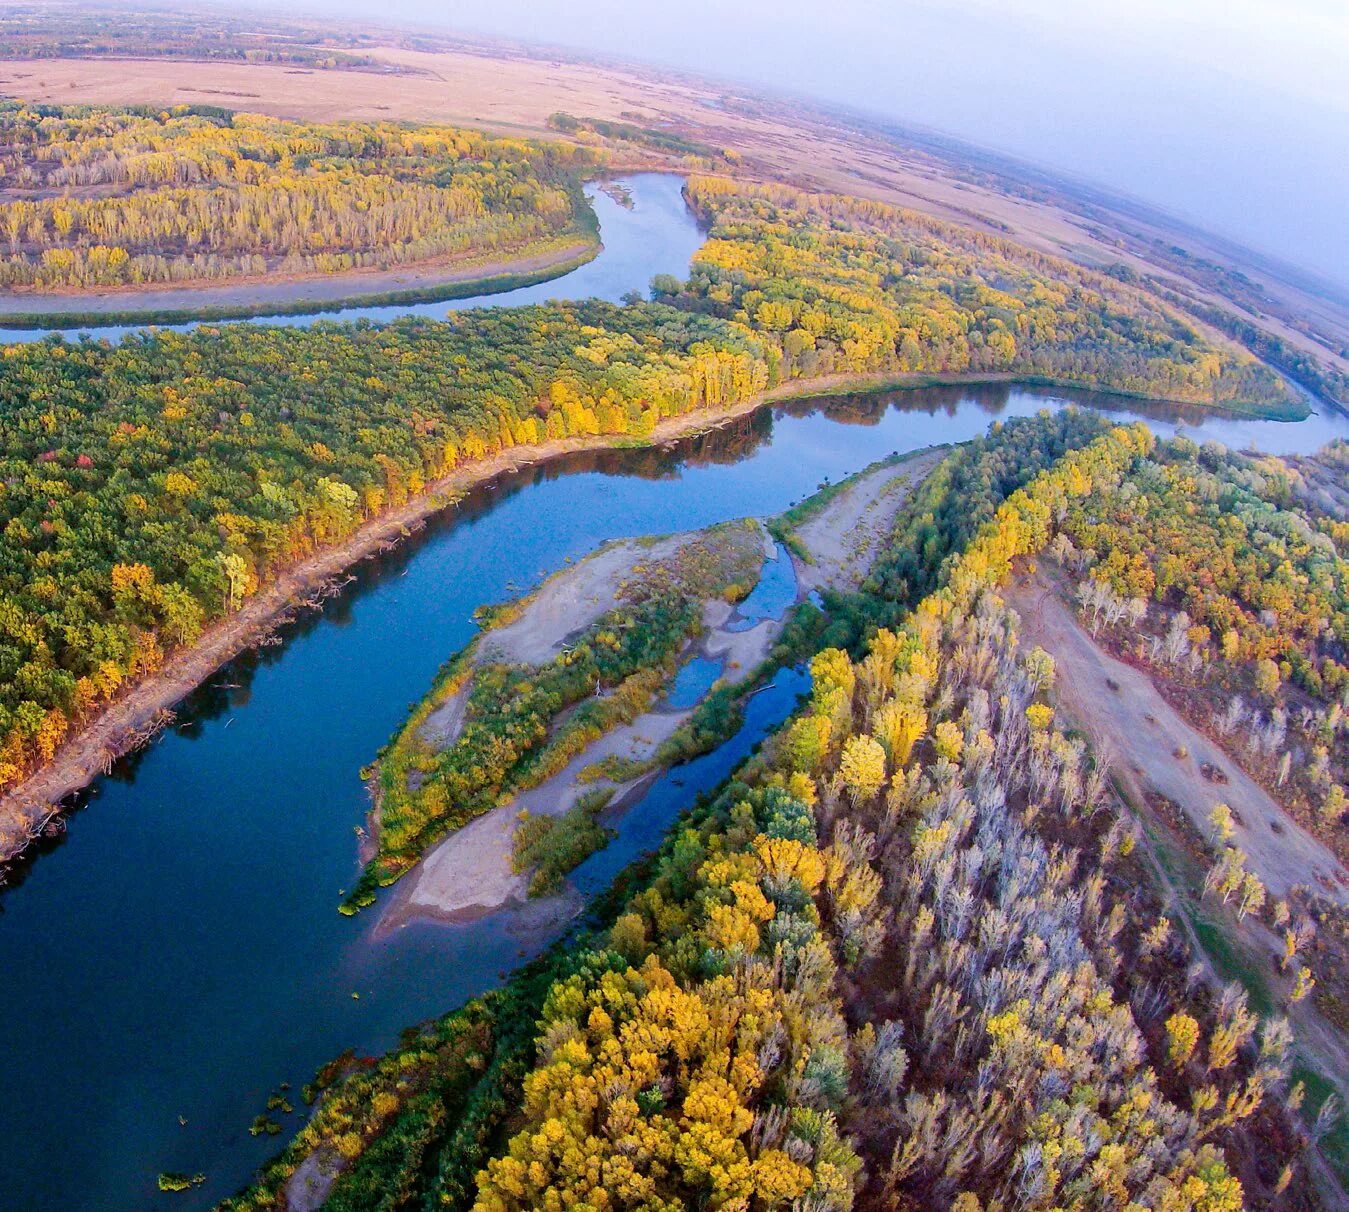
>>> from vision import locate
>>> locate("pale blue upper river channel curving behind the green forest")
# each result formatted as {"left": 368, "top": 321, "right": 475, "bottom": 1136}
{"left": 0, "top": 173, "right": 703, "bottom": 343}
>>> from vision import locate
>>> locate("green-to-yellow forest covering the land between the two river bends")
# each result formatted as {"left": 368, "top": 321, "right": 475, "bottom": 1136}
{"left": 0, "top": 165, "right": 1292, "bottom": 836}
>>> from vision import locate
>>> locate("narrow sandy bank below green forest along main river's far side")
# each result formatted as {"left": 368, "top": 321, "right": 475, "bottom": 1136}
{"left": 0, "top": 373, "right": 1311, "bottom": 869}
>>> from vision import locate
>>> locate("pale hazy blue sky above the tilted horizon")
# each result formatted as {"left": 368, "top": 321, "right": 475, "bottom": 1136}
{"left": 308, "top": 0, "right": 1349, "bottom": 285}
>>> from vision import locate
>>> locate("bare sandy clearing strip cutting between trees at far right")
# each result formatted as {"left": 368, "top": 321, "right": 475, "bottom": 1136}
{"left": 1004, "top": 572, "right": 1349, "bottom": 906}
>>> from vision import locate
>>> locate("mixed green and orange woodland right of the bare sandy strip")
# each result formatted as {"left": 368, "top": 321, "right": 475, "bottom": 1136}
{"left": 1055, "top": 439, "right": 1349, "bottom": 858}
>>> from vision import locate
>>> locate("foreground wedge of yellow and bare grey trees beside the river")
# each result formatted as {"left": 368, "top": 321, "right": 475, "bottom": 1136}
{"left": 225, "top": 414, "right": 1332, "bottom": 1212}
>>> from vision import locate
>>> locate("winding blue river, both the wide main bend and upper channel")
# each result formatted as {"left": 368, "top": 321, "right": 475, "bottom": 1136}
{"left": 0, "top": 177, "right": 1349, "bottom": 1212}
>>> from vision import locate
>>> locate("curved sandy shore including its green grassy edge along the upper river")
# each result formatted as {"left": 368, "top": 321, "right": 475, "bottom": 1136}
{"left": 0, "top": 238, "right": 604, "bottom": 332}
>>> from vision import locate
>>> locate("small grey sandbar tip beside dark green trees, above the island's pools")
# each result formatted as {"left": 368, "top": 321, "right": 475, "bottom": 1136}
{"left": 793, "top": 449, "right": 946, "bottom": 597}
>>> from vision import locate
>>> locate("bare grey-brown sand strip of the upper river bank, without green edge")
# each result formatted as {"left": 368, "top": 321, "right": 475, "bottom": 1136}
{"left": 0, "top": 240, "right": 599, "bottom": 318}
